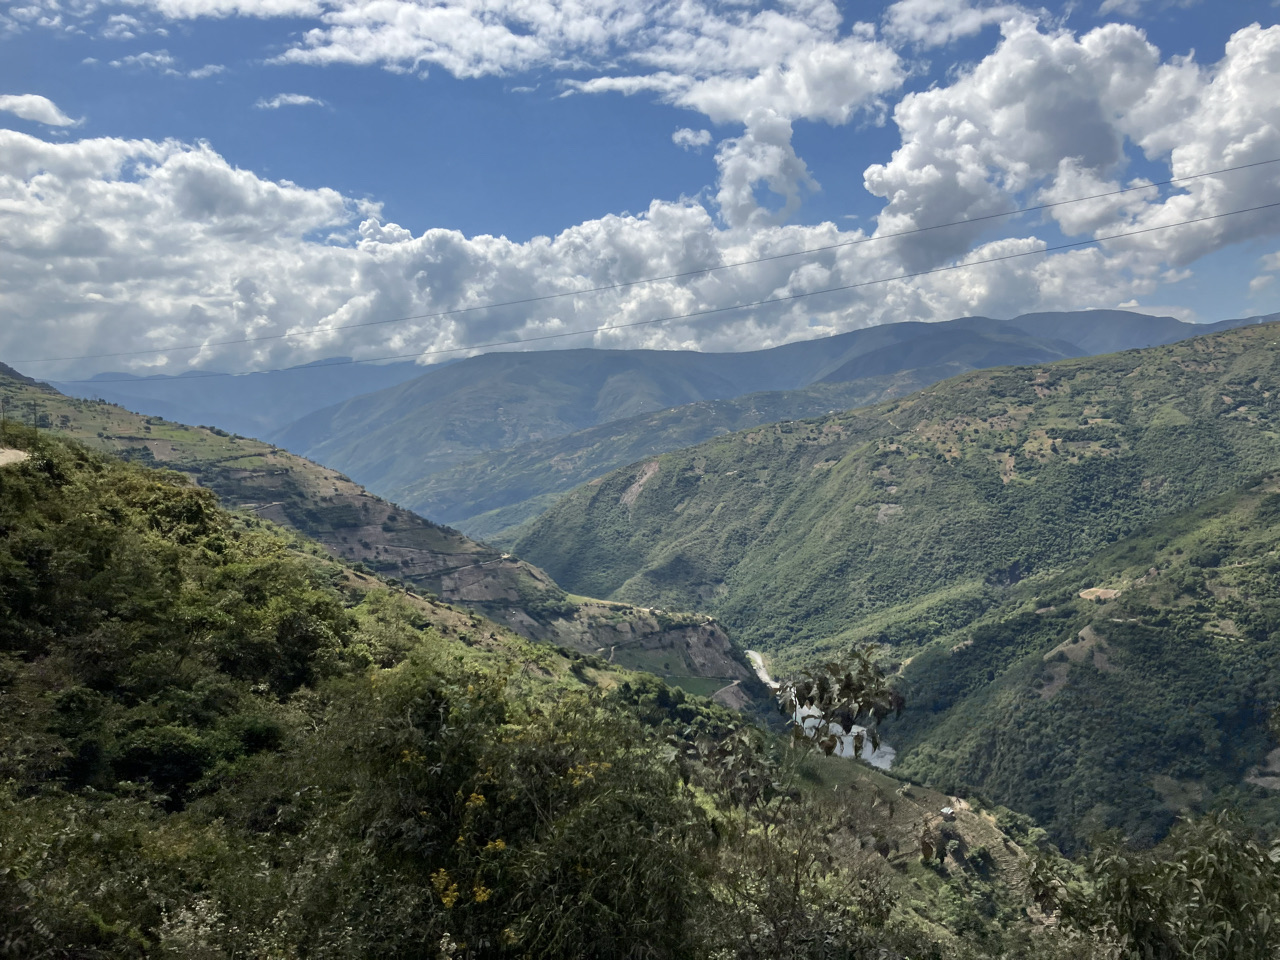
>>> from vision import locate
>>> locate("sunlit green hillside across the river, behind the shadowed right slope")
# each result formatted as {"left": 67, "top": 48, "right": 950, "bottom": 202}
{"left": 515, "top": 325, "right": 1280, "bottom": 650}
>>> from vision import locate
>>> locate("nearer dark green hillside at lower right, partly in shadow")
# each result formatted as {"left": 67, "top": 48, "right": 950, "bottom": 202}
{"left": 888, "top": 477, "right": 1280, "bottom": 845}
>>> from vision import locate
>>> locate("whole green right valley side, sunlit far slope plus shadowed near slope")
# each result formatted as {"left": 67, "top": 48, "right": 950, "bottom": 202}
{"left": 516, "top": 325, "right": 1280, "bottom": 849}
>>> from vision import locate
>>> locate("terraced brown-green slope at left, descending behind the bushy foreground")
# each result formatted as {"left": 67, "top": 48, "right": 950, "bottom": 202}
{"left": 0, "top": 365, "right": 763, "bottom": 707}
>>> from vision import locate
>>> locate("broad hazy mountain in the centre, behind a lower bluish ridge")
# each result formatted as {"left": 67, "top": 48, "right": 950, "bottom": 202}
{"left": 271, "top": 314, "right": 1162, "bottom": 497}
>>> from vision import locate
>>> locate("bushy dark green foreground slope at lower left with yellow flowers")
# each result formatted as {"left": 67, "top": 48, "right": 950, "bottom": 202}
{"left": 0, "top": 425, "right": 1095, "bottom": 960}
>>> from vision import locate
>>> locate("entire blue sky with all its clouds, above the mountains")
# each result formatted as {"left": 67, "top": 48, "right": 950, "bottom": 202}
{"left": 0, "top": 0, "right": 1280, "bottom": 378}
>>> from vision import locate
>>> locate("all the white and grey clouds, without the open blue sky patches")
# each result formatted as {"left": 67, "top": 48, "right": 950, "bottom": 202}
{"left": 0, "top": 8, "right": 1280, "bottom": 376}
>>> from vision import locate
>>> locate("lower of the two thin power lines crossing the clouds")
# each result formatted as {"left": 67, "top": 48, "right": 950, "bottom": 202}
{"left": 55, "top": 201, "right": 1280, "bottom": 384}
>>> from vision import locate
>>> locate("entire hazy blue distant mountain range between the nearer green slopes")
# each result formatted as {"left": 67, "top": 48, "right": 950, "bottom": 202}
{"left": 54, "top": 310, "right": 1258, "bottom": 540}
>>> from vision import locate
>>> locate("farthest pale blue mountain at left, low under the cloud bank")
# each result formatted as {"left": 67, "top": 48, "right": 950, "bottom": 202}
{"left": 52, "top": 357, "right": 424, "bottom": 436}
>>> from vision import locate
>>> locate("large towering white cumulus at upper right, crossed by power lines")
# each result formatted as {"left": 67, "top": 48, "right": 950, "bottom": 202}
{"left": 865, "top": 19, "right": 1280, "bottom": 274}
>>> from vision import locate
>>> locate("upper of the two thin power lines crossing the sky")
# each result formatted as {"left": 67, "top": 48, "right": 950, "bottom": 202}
{"left": 12, "top": 157, "right": 1280, "bottom": 371}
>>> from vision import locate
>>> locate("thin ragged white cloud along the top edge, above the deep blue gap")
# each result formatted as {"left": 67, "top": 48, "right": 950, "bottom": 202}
{"left": 35, "top": 0, "right": 906, "bottom": 129}
